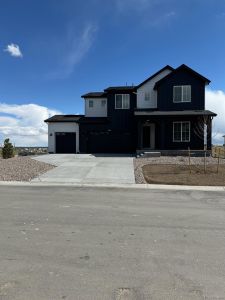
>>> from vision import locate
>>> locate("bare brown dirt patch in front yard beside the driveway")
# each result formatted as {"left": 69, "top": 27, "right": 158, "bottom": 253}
{"left": 142, "top": 164, "right": 225, "bottom": 186}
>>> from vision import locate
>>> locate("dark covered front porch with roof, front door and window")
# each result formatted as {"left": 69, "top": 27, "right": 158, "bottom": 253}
{"left": 135, "top": 110, "right": 216, "bottom": 152}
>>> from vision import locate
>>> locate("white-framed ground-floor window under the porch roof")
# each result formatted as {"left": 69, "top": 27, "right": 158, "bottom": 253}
{"left": 173, "top": 122, "right": 190, "bottom": 142}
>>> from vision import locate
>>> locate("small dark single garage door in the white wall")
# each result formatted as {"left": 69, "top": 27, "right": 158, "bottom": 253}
{"left": 55, "top": 132, "right": 76, "bottom": 153}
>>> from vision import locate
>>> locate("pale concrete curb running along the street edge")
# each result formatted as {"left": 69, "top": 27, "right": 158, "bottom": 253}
{"left": 0, "top": 181, "right": 225, "bottom": 192}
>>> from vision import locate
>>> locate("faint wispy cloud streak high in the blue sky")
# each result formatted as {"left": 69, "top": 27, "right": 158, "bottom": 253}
{"left": 47, "top": 23, "right": 98, "bottom": 79}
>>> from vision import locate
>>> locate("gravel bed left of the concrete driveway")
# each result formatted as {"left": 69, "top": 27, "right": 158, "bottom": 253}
{"left": 0, "top": 156, "right": 55, "bottom": 181}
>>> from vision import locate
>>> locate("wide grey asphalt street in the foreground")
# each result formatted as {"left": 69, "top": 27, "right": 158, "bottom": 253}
{"left": 0, "top": 186, "right": 225, "bottom": 300}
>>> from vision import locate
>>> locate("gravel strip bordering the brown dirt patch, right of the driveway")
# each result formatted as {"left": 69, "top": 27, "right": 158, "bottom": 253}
{"left": 134, "top": 156, "right": 225, "bottom": 184}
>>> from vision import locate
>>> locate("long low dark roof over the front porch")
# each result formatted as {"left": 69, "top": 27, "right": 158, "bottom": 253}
{"left": 134, "top": 109, "right": 217, "bottom": 117}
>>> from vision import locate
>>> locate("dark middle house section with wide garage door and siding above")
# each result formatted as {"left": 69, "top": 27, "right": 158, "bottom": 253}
{"left": 80, "top": 90, "right": 137, "bottom": 153}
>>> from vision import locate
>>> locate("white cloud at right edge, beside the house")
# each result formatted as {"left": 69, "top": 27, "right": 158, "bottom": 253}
{"left": 206, "top": 89, "right": 225, "bottom": 144}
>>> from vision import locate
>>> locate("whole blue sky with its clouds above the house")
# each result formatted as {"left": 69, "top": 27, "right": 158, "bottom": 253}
{"left": 0, "top": 0, "right": 225, "bottom": 145}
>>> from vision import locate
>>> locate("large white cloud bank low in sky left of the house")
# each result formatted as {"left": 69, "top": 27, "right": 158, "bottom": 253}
{"left": 0, "top": 103, "right": 60, "bottom": 146}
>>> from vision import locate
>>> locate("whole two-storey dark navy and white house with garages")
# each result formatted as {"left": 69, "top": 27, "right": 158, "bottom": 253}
{"left": 45, "top": 65, "right": 216, "bottom": 153}
